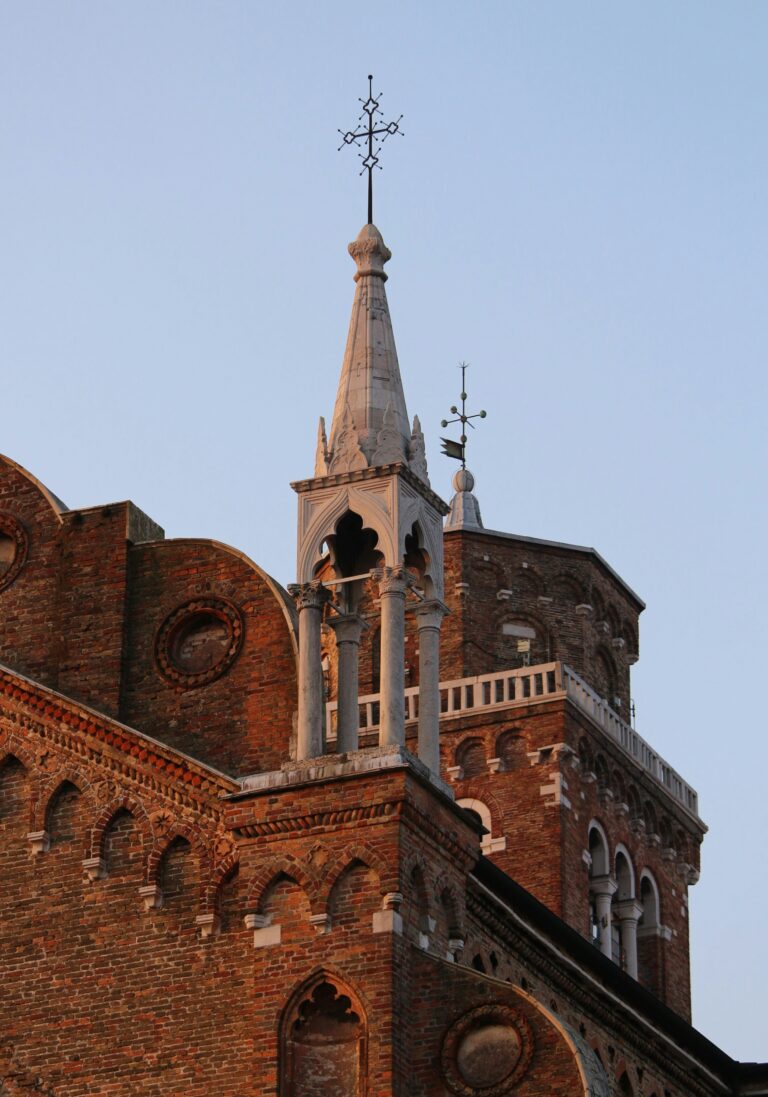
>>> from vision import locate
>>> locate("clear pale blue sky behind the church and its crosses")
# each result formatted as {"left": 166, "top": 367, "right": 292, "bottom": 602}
{"left": 0, "top": 0, "right": 768, "bottom": 1059}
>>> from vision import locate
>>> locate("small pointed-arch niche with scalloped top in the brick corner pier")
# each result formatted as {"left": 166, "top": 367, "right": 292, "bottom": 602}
{"left": 280, "top": 974, "right": 368, "bottom": 1097}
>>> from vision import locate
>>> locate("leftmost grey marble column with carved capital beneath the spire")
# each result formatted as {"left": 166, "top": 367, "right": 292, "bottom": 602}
{"left": 289, "top": 579, "right": 330, "bottom": 761}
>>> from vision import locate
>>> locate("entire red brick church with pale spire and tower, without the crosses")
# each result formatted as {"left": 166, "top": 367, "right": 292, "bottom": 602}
{"left": 0, "top": 224, "right": 768, "bottom": 1097}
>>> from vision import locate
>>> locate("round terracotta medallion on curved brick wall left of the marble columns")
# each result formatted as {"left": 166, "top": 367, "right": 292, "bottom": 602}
{"left": 155, "top": 598, "right": 245, "bottom": 689}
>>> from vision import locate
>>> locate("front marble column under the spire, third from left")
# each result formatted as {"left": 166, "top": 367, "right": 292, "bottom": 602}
{"left": 375, "top": 566, "right": 410, "bottom": 747}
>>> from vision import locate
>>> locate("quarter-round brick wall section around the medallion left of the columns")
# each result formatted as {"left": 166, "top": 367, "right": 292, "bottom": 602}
{"left": 121, "top": 541, "right": 296, "bottom": 773}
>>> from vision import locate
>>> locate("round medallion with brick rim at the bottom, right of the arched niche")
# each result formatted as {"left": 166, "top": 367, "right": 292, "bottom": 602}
{"left": 441, "top": 1005, "right": 533, "bottom": 1097}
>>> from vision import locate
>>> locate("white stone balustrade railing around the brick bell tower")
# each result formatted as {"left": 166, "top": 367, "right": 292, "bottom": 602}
{"left": 326, "top": 663, "right": 699, "bottom": 815}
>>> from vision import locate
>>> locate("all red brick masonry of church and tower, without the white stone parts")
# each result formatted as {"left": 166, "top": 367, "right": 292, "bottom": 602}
{"left": 0, "top": 449, "right": 768, "bottom": 1097}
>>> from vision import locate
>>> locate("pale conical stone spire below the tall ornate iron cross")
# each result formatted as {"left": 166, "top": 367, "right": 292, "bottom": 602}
{"left": 327, "top": 225, "right": 428, "bottom": 483}
